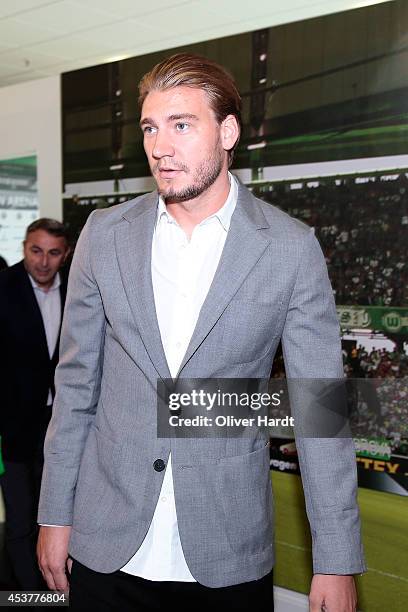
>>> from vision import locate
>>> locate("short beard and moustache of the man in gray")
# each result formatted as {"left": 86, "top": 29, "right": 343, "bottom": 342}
{"left": 153, "top": 147, "right": 223, "bottom": 203}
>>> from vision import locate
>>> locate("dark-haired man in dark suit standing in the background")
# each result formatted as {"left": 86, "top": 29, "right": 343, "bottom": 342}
{"left": 0, "top": 218, "right": 69, "bottom": 590}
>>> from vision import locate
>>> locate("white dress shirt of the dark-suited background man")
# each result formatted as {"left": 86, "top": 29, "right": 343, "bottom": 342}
{"left": 28, "top": 272, "right": 61, "bottom": 406}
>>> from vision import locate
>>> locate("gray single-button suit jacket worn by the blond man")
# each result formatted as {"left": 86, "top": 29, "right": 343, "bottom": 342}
{"left": 38, "top": 185, "right": 364, "bottom": 587}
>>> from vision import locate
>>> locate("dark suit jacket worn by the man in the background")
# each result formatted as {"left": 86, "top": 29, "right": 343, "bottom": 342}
{"left": 0, "top": 261, "right": 66, "bottom": 460}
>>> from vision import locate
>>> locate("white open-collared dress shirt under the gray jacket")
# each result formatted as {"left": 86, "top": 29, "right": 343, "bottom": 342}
{"left": 122, "top": 174, "right": 238, "bottom": 582}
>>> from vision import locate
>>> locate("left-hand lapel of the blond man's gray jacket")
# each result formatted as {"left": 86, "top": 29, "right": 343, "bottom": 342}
{"left": 115, "top": 192, "right": 171, "bottom": 378}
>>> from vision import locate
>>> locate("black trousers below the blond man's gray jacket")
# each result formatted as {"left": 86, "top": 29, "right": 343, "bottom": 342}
{"left": 69, "top": 560, "right": 273, "bottom": 612}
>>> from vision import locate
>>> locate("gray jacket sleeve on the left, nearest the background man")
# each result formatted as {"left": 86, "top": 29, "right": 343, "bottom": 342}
{"left": 38, "top": 213, "right": 106, "bottom": 525}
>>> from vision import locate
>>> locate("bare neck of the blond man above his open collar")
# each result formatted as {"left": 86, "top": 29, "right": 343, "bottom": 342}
{"left": 166, "top": 172, "right": 230, "bottom": 239}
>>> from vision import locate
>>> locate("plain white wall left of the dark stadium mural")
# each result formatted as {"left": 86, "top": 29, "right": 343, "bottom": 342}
{"left": 0, "top": 76, "right": 62, "bottom": 220}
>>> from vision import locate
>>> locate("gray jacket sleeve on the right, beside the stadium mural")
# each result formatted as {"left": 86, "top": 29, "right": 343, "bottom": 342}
{"left": 282, "top": 230, "right": 366, "bottom": 574}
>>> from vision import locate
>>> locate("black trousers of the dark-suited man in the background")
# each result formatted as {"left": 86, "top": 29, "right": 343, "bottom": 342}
{"left": 0, "top": 425, "right": 48, "bottom": 590}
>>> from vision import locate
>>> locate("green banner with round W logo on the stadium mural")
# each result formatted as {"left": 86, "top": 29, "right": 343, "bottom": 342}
{"left": 337, "top": 306, "right": 408, "bottom": 334}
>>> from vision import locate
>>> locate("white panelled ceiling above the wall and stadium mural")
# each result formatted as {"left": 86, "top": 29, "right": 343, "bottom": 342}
{"left": 0, "top": 0, "right": 396, "bottom": 86}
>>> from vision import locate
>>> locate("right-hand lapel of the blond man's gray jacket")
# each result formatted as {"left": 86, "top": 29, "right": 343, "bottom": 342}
{"left": 178, "top": 184, "right": 271, "bottom": 376}
